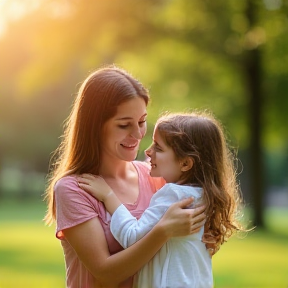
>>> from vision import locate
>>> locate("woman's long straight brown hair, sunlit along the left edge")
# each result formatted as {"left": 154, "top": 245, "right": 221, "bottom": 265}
{"left": 44, "top": 66, "right": 149, "bottom": 224}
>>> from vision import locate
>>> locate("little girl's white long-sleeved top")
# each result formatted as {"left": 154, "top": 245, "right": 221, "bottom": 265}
{"left": 110, "top": 183, "right": 213, "bottom": 288}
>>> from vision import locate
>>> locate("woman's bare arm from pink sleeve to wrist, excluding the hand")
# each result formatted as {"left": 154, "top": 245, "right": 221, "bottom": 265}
{"left": 64, "top": 218, "right": 169, "bottom": 287}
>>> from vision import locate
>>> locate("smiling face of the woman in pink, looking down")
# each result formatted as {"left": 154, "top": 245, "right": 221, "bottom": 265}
{"left": 101, "top": 97, "right": 147, "bottom": 161}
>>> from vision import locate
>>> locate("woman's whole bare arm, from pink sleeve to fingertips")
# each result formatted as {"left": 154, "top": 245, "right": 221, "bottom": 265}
{"left": 63, "top": 199, "right": 205, "bottom": 287}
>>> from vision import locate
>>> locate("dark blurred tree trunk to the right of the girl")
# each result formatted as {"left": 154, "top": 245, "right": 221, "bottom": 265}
{"left": 244, "top": 0, "right": 264, "bottom": 227}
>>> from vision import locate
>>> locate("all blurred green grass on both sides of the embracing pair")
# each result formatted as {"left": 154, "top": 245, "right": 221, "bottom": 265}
{"left": 0, "top": 202, "right": 288, "bottom": 288}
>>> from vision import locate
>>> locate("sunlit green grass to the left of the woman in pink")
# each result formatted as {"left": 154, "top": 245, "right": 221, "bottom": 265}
{"left": 0, "top": 202, "right": 65, "bottom": 288}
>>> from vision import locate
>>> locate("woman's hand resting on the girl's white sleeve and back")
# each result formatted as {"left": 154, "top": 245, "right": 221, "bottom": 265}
{"left": 157, "top": 198, "right": 206, "bottom": 238}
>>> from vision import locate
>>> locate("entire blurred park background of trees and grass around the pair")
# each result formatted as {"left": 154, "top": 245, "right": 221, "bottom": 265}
{"left": 0, "top": 0, "right": 288, "bottom": 288}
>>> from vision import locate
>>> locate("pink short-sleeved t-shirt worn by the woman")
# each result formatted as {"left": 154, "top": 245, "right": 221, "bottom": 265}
{"left": 54, "top": 161, "right": 164, "bottom": 288}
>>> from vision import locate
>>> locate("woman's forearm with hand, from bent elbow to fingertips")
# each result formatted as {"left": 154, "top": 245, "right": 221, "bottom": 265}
{"left": 94, "top": 199, "right": 205, "bottom": 287}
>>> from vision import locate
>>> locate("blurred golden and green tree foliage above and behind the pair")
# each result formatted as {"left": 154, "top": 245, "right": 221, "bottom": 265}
{"left": 0, "top": 0, "right": 288, "bottom": 194}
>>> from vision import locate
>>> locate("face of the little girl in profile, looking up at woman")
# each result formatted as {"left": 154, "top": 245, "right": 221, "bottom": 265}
{"left": 146, "top": 126, "right": 182, "bottom": 183}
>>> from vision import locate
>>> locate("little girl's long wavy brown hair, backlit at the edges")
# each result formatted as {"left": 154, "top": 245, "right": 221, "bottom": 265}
{"left": 156, "top": 111, "right": 246, "bottom": 255}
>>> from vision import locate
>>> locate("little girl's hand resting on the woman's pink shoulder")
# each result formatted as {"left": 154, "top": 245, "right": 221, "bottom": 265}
{"left": 77, "top": 174, "right": 114, "bottom": 202}
